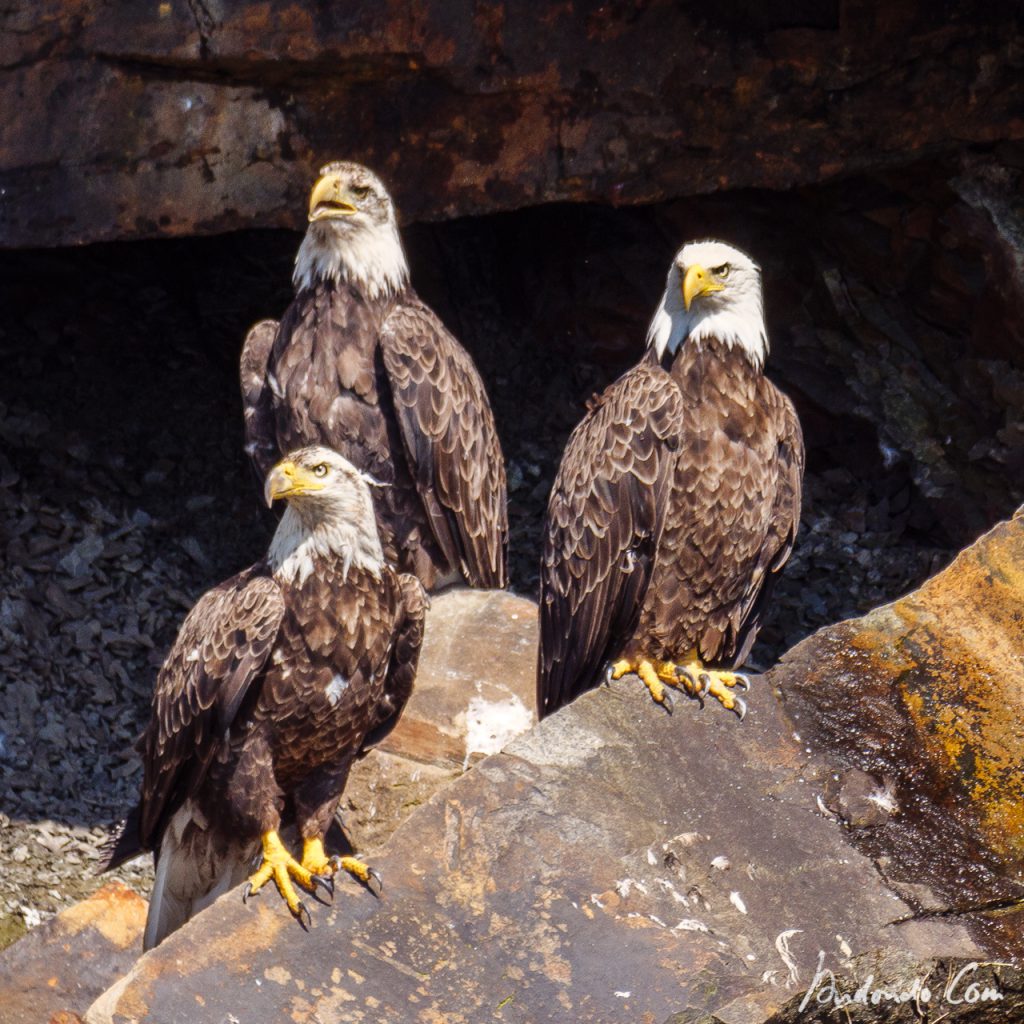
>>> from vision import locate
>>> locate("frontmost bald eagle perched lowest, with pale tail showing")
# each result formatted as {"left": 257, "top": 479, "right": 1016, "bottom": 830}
{"left": 109, "top": 447, "right": 426, "bottom": 949}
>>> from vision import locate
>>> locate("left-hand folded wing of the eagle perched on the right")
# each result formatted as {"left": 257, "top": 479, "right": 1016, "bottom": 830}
{"left": 537, "top": 364, "right": 681, "bottom": 718}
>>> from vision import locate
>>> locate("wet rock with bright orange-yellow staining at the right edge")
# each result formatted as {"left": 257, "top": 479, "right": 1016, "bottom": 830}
{"left": 769, "top": 509, "right": 1024, "bottom": 956}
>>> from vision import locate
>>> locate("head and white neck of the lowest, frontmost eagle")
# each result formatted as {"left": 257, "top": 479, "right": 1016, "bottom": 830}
{"left": 263, "top": 444, "right": 384, "bottom": 584}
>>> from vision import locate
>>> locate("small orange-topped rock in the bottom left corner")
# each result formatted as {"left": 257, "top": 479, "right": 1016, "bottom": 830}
{"left": 0, "top": 882, "right": 145, "bottom": 1024}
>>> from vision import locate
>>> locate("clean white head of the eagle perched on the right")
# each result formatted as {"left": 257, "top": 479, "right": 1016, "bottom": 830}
{"left": 647, "top": 241, "right": 768, "bottom": 369}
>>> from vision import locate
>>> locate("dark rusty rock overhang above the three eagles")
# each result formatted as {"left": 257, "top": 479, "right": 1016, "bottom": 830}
{"left": 0, "top": 0, "right": 1024, "bottom": 246}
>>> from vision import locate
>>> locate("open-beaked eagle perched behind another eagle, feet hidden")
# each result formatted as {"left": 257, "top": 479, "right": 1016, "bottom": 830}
{"left": 241, "top": 163, "right": 508, "bottom": 590}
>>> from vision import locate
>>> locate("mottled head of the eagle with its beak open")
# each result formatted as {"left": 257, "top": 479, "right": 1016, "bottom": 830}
{"left": 293, "top": 160, "right": 409, "bottom": 299}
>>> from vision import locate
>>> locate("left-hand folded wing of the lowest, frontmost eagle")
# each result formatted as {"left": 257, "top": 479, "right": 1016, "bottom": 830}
{"left": 139, "top": 567, "right": 285, "bottom": 849}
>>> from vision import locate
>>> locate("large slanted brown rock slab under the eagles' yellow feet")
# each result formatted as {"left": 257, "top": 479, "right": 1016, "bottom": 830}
{"left": 87, "top": 679, "right": 980, "bottom": 1024}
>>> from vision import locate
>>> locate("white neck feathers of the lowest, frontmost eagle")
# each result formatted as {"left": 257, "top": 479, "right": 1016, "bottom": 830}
{"left": 266, "top": 499, "right": 384, "bottom": 587}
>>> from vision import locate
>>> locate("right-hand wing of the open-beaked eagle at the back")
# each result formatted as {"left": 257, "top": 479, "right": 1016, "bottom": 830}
{"left": 381, "top": 300, "right": 508, "bottom": 587}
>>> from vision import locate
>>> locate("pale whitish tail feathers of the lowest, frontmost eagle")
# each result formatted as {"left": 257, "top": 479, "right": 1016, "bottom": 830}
{"left": 142, "top": 803, "right": 259, "bottom": 949}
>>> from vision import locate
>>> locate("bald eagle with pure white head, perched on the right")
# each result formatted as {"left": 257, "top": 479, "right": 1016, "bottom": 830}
{"left": 537, "top": 242, "right": 804, "bottom": 717}
